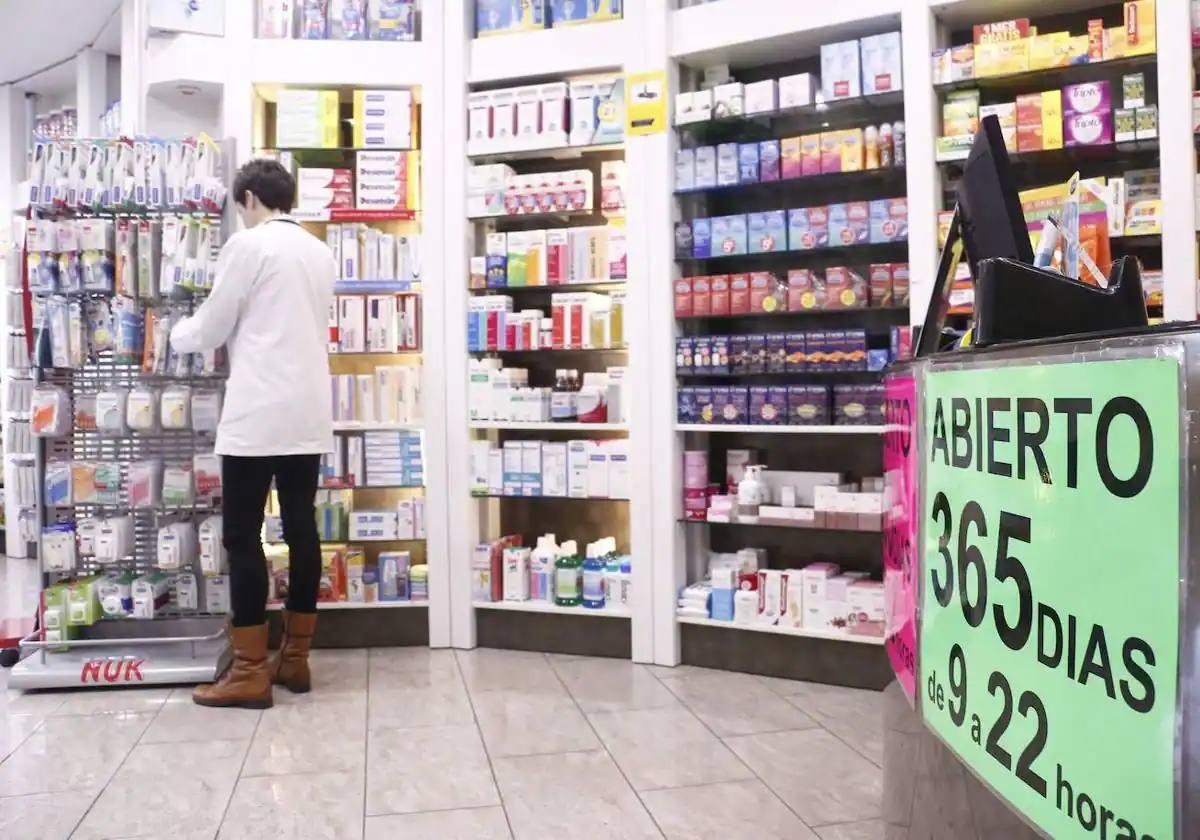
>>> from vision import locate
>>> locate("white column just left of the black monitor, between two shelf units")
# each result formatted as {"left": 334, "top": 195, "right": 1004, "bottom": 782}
{"left": 900, "top": 2, "right": 942, "bottom": 324}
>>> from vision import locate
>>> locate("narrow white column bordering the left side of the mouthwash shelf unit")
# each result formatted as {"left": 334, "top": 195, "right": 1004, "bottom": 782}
{"left": 446, "top": 0, "right": 480, "bottom": 648}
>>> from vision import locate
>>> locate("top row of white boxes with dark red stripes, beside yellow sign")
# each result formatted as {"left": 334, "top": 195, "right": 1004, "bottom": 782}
{"left": 467, "top": 76, "right": 625, "bottom": 155}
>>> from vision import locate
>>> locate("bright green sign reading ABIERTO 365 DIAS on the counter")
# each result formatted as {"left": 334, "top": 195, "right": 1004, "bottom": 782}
{"left": 919, "top": 358, "right": 1181, "bottom": 840}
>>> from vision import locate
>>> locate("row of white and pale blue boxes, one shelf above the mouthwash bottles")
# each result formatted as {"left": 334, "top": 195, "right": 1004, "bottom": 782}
{"left": 470, "top": 438, "right": 631, "bottom": 499}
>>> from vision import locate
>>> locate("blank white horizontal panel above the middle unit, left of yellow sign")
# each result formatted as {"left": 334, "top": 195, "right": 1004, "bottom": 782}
{"left": 467, "top": 21, "right": 628, "bottom": 83}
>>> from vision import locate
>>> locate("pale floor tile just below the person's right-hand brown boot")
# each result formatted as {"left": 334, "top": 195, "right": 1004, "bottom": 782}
{"left": 241, "top": 700, "right": 366, "bottom": 776}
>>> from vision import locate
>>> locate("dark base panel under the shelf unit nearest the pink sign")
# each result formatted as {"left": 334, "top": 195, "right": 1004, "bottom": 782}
{"left": 679, "top": 624, "right": 893, "bottom": 691}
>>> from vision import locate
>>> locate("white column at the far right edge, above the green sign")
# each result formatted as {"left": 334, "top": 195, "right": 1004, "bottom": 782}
{"left": 1157, "top": 2, "right": 1196, "bottom": 320}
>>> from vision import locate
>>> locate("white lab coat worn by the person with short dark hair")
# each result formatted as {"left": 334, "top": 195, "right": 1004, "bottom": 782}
{"left": 170, "top": 213, "right": 337, "bottom": 457}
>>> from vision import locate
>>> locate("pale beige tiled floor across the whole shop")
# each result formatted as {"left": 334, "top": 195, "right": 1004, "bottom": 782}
{"left": 0, "top": 648, "right": 883, "bottom": 840}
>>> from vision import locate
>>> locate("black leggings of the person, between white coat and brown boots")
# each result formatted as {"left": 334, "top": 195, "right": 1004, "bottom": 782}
{"left": 221, "top": 455, "right": 320, "bottom": 628}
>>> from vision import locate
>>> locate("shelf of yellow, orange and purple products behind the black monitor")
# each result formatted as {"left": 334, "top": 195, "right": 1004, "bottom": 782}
{"left": 932, "top": 2, "right": 1164, "bottom": 329}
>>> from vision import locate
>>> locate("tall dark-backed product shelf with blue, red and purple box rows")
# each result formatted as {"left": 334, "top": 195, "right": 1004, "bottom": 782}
{"left": 655, "top": 16, "right": 911, "bottom": 686}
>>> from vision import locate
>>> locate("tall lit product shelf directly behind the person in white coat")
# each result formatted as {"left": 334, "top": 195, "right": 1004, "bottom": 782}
{"left": 253, "top": 84, "right": 431, "bottom": 644}
